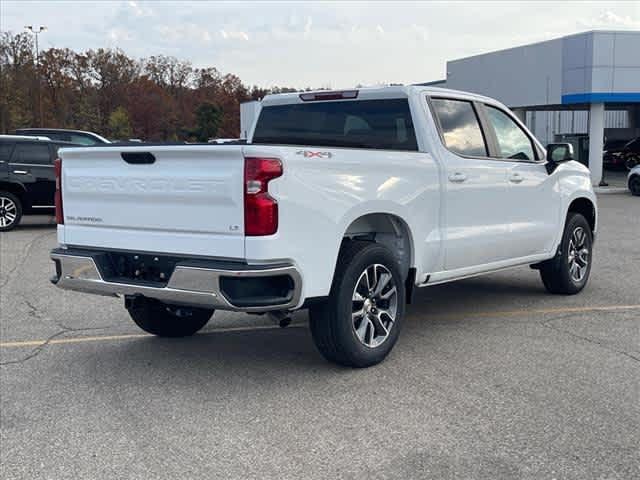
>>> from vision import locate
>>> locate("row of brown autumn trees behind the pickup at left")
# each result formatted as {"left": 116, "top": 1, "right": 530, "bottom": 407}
{"left": 0, "top": 31, "right": 320, "bottom": 140}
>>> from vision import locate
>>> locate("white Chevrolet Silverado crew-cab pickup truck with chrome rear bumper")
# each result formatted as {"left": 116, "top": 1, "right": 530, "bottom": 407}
{"left": 51, "top": 86, "right": 597, "bottom": 367}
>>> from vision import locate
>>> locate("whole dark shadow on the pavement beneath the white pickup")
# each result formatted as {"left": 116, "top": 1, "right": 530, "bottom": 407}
{"left": 67, "top": 278, "right": 546, "bottom": 384}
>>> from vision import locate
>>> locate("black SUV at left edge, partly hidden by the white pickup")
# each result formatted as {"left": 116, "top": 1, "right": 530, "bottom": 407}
{"left": 0, "top": 135, "right": 77, "bottom": 232}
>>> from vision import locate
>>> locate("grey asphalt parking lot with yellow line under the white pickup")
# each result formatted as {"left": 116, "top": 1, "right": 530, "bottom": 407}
{"left": 0, "top": 193, "right": 640, "bottom": 479}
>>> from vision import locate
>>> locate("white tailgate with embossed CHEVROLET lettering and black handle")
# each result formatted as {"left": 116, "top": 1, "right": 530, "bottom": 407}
{"left": 60, "top": 145, "right": 244, "bottom": 258}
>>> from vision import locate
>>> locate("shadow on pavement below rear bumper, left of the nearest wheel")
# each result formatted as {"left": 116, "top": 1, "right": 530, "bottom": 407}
{"left": 81, "top": 325, "right": 336, "bottom": 390}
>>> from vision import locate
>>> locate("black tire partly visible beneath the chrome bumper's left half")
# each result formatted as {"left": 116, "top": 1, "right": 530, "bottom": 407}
{"left": 127, "top": 298, "right": 213, "bottom": 337}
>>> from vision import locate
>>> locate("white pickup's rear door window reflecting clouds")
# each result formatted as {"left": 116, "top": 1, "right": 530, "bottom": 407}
{"left": 431, "top": 98, "right": 488, "bottom": 157}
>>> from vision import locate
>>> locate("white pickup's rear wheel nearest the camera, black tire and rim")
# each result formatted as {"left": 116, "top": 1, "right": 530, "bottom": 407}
{"left": 309, "top": 240, "right": 405, "bottom": 368}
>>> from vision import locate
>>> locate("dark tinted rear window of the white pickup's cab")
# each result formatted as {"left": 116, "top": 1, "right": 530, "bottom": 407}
{"left": 253, "top": 99, "right": 418, "bottom": 151}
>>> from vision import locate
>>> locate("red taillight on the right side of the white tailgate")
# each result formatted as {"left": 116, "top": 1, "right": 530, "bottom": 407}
{"left": 244, "top": 157, "right": 282, "bottom": 236}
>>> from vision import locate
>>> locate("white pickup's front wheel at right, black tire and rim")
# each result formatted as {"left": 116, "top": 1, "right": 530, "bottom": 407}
{"left": 540, "top": 212, "right": 593, "bottom": 295}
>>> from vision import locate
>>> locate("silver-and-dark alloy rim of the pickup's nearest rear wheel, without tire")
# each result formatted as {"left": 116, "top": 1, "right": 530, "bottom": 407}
{"left": 351, "top": 263, "right": 398, "bottom": 348}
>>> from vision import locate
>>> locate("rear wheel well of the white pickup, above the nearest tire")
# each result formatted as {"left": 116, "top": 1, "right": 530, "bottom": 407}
{"left": 343, "top": 213, "right": 415, "bottom": 301}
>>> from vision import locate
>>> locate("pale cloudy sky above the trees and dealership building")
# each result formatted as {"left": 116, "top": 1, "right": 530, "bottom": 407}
{"left": 0, "top": 0, "right": 640, "bottom": 88}
